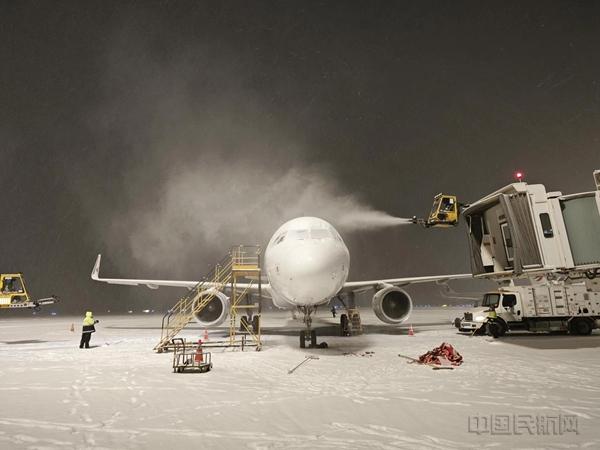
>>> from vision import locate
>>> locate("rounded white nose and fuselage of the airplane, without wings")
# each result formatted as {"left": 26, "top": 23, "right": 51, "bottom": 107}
{"left": 265, "top": 217, "right": 350, "bottom": 308}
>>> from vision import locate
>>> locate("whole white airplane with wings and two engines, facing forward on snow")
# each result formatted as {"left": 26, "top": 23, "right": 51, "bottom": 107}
{"left": 91, "top": 217, "right": 472, "bottom": 346}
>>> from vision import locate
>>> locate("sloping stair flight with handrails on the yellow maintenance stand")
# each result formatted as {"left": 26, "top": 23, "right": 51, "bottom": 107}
{"left": 154, "top": 255, "right": 233, "bottom": 353}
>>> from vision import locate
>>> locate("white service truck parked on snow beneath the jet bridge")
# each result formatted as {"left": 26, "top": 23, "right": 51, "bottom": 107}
{"left": 454, "top": 280, "right": 600, "bottom": 335}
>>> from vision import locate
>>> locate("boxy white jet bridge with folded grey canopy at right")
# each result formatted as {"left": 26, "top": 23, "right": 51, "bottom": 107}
{"left": 463, "top": 171, "right": 600, "bottom": 278}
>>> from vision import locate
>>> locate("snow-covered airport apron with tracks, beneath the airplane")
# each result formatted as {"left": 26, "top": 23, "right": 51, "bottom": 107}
{"left": 0, "top": 308, "right": 600, "bottom": 449}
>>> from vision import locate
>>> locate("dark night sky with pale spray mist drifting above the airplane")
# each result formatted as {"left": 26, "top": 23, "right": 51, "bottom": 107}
{"left": 0, "top": 1, "right": 600, "bottom": 312}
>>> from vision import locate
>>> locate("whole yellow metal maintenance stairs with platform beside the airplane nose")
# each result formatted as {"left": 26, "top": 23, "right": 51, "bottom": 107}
{"left": 154, "top": 245, "right": 262, "bottom": 353}
